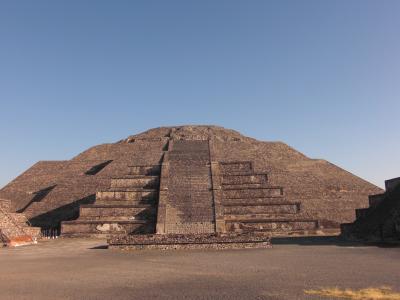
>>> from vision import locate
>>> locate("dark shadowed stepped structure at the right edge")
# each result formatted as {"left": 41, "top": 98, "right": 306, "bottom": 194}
{"left": 340, "top": 177, "right": 400, "bottom": 241}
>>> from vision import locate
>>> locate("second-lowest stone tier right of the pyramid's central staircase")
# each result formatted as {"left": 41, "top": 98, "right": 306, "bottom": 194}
{"left": 224, "top": 203, "right": 300, "bottom": 216}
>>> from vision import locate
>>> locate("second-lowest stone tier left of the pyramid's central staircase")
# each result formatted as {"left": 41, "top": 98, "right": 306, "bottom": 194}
{"left": 79, "top": 204, "right": 156, "bottom": 219}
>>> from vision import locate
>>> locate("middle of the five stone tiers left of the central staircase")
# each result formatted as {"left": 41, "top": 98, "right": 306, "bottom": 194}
{"left": 96, "top": 189, "right": 158, "bottom": 202}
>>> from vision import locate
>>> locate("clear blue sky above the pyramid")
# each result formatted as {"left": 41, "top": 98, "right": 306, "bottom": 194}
{"left": 0, "top": 0, "right": 400, "bottom": 186}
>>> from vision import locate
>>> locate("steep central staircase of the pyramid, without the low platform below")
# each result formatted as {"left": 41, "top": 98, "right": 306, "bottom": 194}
{"left": 158, "top": 140, "right": 215, "bottom": 234}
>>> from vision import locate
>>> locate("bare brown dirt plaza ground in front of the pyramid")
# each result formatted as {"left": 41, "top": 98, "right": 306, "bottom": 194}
{"left": 0, "top": 237, "right": 400, "bottom": 300}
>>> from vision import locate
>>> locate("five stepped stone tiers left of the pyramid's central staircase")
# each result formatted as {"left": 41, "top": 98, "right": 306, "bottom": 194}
{"left": 61, "top": 165, "right": 161, "bottom": 237}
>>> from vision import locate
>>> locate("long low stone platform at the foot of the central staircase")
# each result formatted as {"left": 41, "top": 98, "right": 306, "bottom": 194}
{"left": 108, "top": 233, "right": 271, "bottom": 250}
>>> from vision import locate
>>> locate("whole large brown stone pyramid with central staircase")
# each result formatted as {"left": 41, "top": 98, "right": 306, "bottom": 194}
{"left": 0, "top": 126, "right": 381, "bottom": 248}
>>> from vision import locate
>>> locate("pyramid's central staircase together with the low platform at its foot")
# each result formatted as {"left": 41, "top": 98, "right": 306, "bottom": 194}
{"left": 108, "top": 139, "right": 270, "bottom": 249}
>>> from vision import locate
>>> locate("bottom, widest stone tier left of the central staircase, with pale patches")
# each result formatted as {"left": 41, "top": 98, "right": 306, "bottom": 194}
{"left": 61, "top": 220, "right": 155, "bottom": 236}
